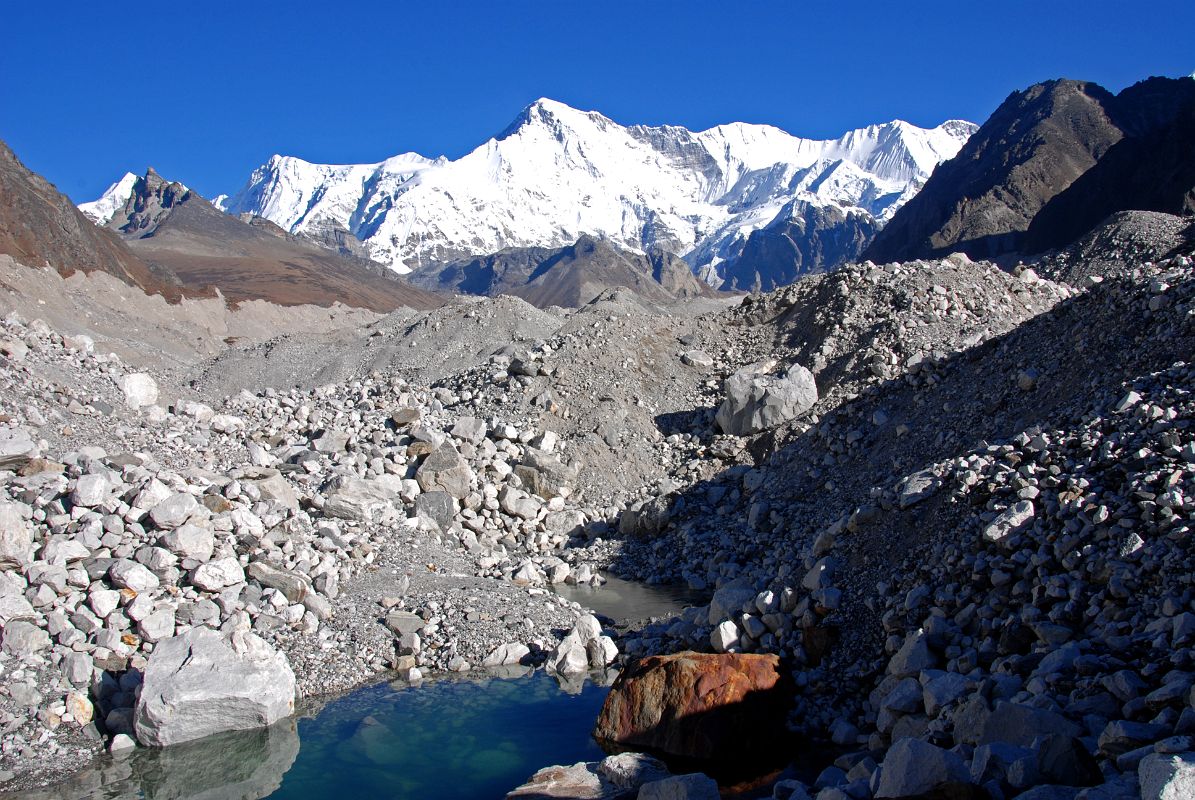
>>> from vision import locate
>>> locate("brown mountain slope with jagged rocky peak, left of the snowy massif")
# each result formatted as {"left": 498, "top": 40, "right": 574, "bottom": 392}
{"left": 109, "top": 170, "right": 442, "bottom": 312}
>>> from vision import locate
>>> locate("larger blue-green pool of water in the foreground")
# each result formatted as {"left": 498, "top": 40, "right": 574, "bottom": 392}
{"left": 5, "top": 671, "right": 607, "bottom": 800}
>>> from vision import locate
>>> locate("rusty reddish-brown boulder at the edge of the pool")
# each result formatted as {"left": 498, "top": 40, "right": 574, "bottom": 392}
{"left": 594, "top": 653, "right": 792, "bottom": 759}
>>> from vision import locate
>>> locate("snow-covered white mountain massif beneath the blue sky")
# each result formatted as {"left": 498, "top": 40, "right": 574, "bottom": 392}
{"left": 195, "top": 98, "right": 976, "bottom": 281}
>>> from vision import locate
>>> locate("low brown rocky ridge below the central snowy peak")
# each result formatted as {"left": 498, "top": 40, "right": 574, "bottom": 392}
{"left": 410, "top": 236, "right": 717, "bottom": 309}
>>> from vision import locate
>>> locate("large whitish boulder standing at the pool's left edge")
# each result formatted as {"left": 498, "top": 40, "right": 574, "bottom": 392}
{"left": 134, "top": 628, "right": 295, "bottom": 747}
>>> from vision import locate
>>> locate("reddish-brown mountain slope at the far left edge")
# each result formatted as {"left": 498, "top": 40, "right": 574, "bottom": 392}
{"left": 0, "top": 141, "right": 180, "bottom": 299}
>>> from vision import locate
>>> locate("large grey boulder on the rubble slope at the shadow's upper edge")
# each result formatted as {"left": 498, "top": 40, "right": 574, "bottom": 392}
{"left": 715, "top": 365, "right": 817, "bottom": 436}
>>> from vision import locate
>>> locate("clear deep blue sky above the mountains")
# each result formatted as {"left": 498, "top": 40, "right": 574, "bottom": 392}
{"left": 0, "top": 0, "right": 1195, "bottom": 201}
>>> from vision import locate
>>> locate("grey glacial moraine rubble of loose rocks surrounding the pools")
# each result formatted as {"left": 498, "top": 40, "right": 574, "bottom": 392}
{"left": 0, "top": 226, "right": 1195, "bottom": 800}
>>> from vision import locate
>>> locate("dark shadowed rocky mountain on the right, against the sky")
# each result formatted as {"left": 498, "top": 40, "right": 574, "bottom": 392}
{"left": 864, "top": 78, "right": 1195, "bottom": 262}
